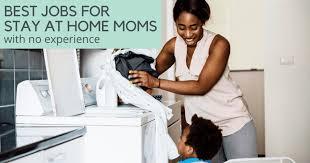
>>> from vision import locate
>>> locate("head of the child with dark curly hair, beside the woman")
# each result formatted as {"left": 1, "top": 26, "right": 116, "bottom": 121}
{"left": 178, "top": 114, "right": 222, "bottom": 160}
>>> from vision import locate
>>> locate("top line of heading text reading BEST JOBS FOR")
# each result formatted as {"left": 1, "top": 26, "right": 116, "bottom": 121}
{"left": 4, "top": 5, "right": 110, "bottom": 17}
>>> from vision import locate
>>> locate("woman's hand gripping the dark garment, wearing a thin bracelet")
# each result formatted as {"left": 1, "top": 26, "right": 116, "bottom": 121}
{"left": 128, "top": 70, "right": 160, "bottom": 88}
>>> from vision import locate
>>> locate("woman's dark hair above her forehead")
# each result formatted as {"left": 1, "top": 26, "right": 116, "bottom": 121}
{"left": 173, "top": 0, "right": 211, "bottom": 24}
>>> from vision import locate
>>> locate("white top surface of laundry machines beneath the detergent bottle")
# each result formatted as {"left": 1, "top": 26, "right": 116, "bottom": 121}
{"left": 16, "top": 106, "right": 155, "bottom": 127}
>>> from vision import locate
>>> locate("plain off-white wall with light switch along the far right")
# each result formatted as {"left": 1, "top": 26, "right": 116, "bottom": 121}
{"left": 264, "top": 0, "right": 310, "bottom": 163}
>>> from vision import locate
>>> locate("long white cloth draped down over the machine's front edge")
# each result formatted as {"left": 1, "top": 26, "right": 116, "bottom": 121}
{"left": 103, "top": 55, "right": 178, "bottom": 163}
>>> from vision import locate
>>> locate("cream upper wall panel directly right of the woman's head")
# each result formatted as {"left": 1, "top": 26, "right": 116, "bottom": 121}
{"left": 206, "top": 0, "right": 264, "bottom": 70}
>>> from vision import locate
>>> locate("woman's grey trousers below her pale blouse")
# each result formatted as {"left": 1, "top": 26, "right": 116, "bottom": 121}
{"left": 212, "top": 120, "right": 257, "bottom": 163}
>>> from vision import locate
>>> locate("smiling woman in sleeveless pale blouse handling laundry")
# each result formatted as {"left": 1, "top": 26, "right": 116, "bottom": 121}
{"left": 129, "top": 0, "right": 257, "bottom": 162}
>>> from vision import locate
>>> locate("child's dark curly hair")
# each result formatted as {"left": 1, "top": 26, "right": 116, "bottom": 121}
{"left": 185, "top": 114, "right": 222, "bottom": 160}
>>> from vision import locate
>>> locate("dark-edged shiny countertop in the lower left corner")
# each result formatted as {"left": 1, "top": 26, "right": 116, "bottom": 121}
{"left": 0, "top": 124, "right": 86, "bottom": 162}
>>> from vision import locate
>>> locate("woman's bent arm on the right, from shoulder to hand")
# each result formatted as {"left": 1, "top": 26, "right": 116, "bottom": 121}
{"left": 131, "top": 35, "right": 230, "bottom": 95}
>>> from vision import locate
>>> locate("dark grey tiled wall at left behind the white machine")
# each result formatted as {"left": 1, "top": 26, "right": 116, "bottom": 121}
{"left": 0, "top": 49, "right": 46, "bottom": 124}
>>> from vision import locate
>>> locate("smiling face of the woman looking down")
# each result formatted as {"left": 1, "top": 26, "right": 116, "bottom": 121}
{"left": 176, "top": 11, "right": 203, "bottom": 46}
